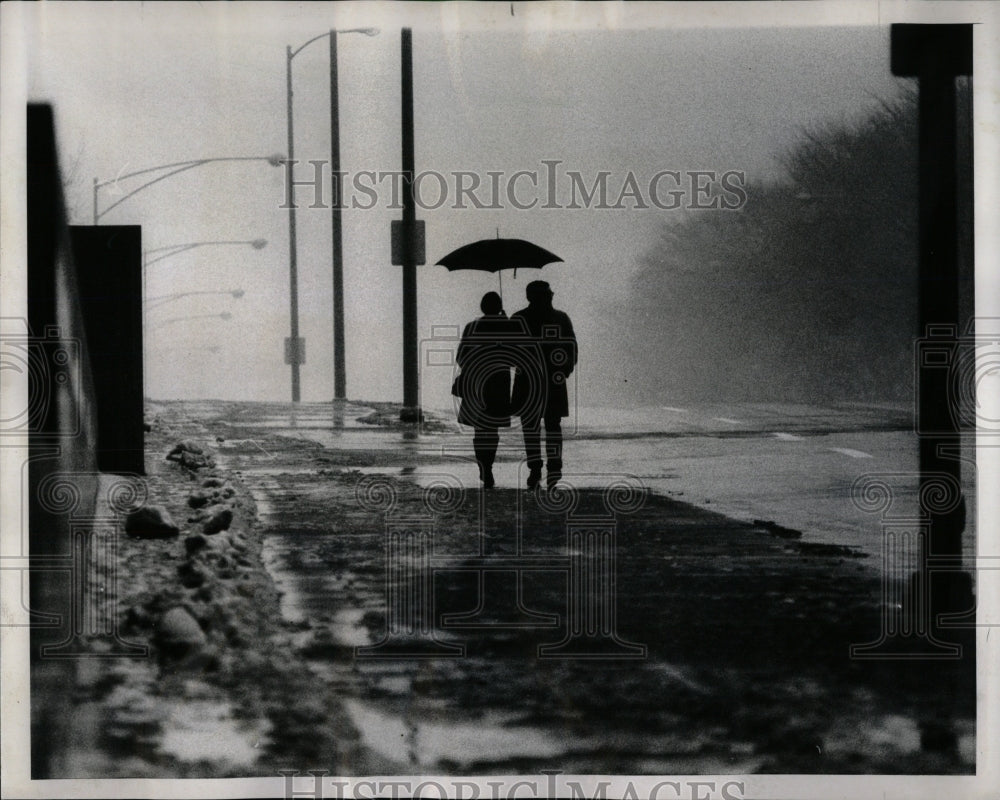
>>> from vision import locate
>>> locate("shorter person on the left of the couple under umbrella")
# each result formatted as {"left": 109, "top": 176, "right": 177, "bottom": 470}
{"left": 452, "top": 292, "right": 520, "bottom": 489}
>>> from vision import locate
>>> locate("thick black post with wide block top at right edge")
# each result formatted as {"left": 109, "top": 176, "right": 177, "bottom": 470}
{"left": 891, "top": 24, "right": 976, "bottom": 753}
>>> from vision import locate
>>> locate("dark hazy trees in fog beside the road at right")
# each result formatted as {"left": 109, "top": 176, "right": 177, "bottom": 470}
{"left": 609, "top": 85, "right": 972, "bottom": 402}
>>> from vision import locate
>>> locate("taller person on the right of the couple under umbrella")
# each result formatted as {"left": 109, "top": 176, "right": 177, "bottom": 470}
{"left": 510, "top": 281, "right": 577, "bottom": 489}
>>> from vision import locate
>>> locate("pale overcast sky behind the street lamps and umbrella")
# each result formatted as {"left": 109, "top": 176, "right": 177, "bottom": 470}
{"left": 21, "top": 3, "right": 916, "bottom": 407}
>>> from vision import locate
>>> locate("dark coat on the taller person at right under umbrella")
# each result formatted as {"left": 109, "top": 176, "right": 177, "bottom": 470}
{"left": 510, "top": 304, "right": 577, "bottom": 417}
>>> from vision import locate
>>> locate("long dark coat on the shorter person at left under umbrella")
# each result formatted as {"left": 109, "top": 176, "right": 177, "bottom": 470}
{"left": 456, "top": 315, "right": 523, "bottom": 428}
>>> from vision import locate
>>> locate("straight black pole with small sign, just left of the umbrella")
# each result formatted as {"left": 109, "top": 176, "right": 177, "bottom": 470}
{"left": 400, "top": 28, "right": 419, "bottom": 412}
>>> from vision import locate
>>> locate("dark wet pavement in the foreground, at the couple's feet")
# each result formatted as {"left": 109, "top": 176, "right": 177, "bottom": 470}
{"left": 178, "top": 403, "right": 975, "bottom": 774}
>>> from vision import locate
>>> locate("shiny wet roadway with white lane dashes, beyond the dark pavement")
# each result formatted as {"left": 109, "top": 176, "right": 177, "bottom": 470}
{"left": 250, "top": 403, "right": 975, "bottom": 560}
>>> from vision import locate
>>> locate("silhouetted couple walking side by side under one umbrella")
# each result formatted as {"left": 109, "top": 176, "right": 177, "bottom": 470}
{"left": 452, "top": 281, "right": 577, "bottom": 489}
